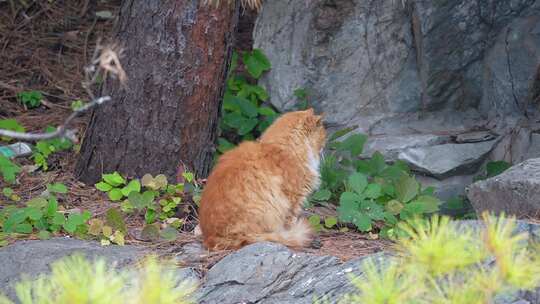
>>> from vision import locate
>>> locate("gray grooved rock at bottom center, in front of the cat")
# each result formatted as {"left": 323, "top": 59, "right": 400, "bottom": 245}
{"left": 199, "top": 243, "right": 376, "bottom": 304}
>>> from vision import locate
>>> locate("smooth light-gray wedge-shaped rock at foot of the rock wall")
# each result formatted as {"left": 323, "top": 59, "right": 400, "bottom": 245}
{"left": 398, "top": 140, "right": 496, "bottom": 179}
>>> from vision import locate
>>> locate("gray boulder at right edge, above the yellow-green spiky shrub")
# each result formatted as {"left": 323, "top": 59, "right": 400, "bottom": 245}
{"left": 467, "top": 158, "right": 540, "bottom": 217}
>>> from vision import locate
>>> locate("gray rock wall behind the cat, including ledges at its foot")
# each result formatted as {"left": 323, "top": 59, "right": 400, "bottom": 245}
{"left": 254, "top": 0, "right": 540, "bottom": 200}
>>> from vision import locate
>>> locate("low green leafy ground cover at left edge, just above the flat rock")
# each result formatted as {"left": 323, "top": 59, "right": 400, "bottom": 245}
{"left": 0, "top": 183, "right": 91, "bottom": 238}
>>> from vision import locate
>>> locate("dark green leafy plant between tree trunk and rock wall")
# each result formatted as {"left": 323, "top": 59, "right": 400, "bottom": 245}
{"left": 217, "top": 49, "right": 278, "bottom": 153}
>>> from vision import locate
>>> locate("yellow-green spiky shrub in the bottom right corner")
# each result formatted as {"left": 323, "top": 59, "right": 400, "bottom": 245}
{"left": 342, "top": 214, "right": 540, "bottom": 304}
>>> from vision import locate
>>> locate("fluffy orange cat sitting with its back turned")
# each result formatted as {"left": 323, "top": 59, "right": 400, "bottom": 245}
{"left": 199, "top": 109, "right": 326, "bottom": 250}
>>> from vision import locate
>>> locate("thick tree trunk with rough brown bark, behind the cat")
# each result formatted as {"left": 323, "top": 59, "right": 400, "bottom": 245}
{"left": 76, "top": 0, "right": 238, "bottom": 183}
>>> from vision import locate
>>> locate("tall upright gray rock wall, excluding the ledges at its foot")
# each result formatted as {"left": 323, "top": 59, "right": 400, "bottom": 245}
{"left": 254, "top": 0, "right": 540, "bottom": 127}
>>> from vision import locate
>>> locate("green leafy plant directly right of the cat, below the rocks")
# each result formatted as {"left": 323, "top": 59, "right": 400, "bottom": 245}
{"left": 309, "top": 129, "right": 440, "bottom": 237}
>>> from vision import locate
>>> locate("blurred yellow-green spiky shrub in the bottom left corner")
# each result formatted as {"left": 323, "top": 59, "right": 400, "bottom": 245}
{"left": 0, "top": 255, "right": 196, "bottom": 304}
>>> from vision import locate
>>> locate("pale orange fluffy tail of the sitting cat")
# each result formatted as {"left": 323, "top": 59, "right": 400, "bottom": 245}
{"left": 249, "top": 219, "right": 313, "bottom": 248}
